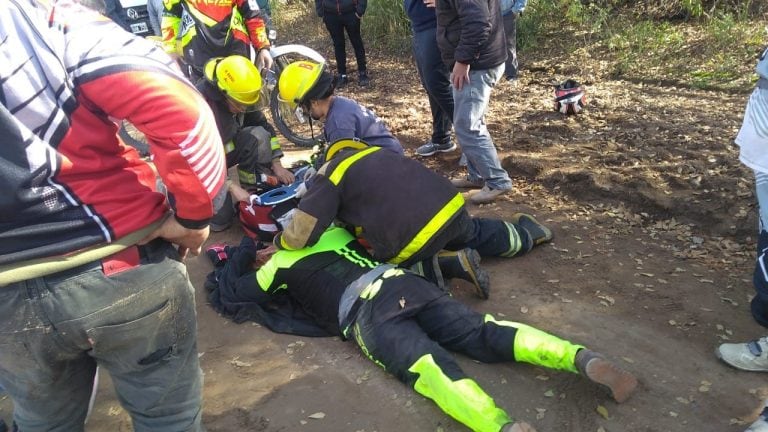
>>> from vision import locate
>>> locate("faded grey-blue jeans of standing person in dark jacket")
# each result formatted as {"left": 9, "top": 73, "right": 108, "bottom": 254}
{"left": 453, "top": 63, "right": 512, "bottom": 190}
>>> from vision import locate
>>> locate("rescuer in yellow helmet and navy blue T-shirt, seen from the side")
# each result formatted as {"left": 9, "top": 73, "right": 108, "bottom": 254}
{"left": 278, "top": 61, "right": 403, "bottom": 154}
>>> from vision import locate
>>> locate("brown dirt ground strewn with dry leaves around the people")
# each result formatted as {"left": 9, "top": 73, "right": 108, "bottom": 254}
{"left": 0, "top": 30, "right": 768, "bottom": 432}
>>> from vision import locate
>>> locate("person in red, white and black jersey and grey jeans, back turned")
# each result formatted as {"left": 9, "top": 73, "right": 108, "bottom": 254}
{"left": 0, "top": 0, "right": 225, "bottom": 431}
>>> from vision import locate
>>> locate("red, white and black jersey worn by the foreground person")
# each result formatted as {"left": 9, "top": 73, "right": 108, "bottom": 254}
{"left": 0, "top": 0, "right": 226, "bottom": 264}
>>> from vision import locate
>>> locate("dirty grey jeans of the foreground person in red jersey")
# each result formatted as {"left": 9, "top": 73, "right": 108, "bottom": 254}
{"left": 0, "top": 240, "right": 204, "bottom": 432}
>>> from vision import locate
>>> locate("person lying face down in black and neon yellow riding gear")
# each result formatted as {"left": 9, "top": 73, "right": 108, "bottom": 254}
{"left": 206, "top": 227, "right": 637, "bottom": 432}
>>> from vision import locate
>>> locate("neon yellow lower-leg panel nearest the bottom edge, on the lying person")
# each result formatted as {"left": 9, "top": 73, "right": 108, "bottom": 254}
{"left": 408, "top": 354, "right": 512, "bottom": 432}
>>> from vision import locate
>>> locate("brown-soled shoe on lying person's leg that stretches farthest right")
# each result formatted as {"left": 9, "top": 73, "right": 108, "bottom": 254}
{"left": 574, "top": 349, "right": 637, "bottom": 403}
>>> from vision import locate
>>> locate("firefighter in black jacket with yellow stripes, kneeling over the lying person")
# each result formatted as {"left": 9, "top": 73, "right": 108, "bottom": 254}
{"left": 274, "top": 140, "right": 553, "bottom": 298}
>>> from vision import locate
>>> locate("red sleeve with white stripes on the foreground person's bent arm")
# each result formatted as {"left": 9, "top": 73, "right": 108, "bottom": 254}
{"left": 80, "top": 69, "right": 226, "bottom": 227}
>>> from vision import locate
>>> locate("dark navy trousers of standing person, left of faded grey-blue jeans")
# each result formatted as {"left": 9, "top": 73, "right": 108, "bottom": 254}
{"left": 413, "top": 28, "right": 453, "bottom": 144}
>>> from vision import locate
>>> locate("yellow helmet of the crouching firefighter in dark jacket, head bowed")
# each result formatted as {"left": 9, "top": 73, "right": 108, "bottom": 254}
{"left": 205, "top": 55, "right": 261, "bottom": 107}
